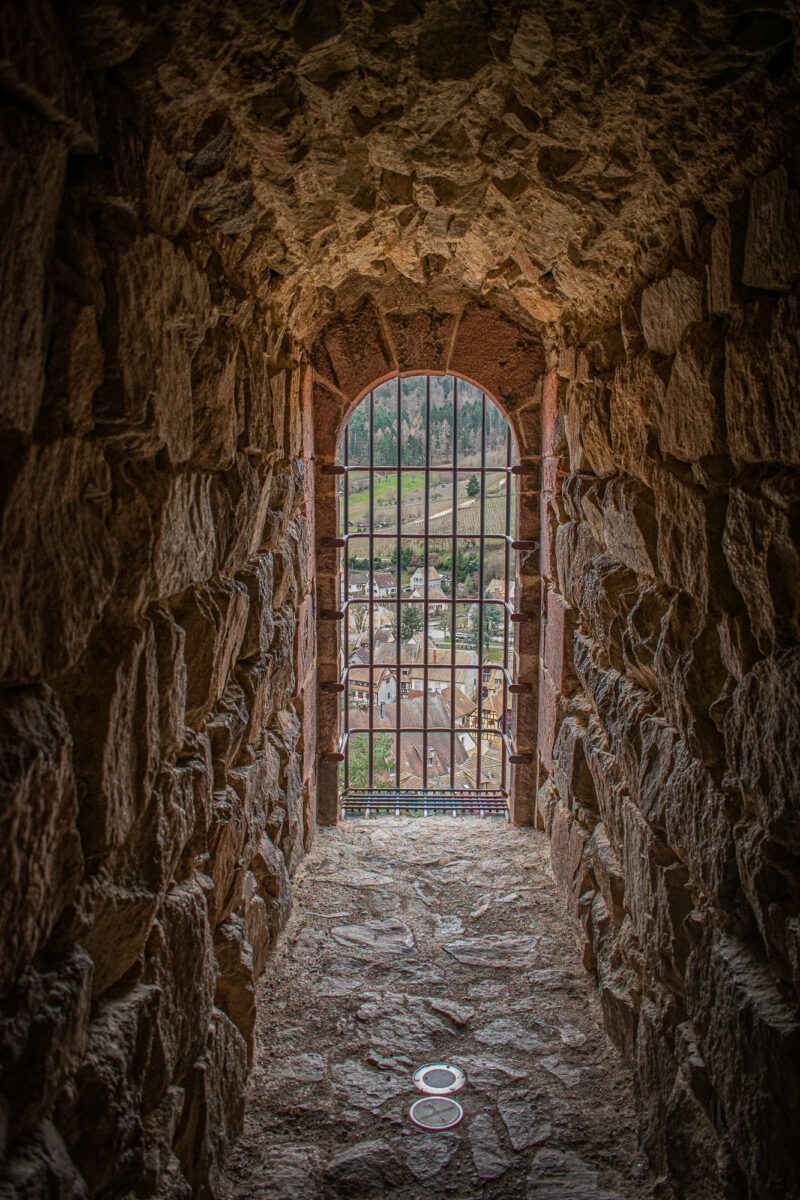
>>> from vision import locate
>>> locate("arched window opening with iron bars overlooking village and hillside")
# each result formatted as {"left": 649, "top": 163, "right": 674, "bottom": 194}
{"left": 336, "top": 374, "right": 517, "bottom": 812}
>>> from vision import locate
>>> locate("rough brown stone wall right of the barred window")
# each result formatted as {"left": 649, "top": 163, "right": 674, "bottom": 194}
{"left": 537, "top": 156, "right": 800, "bottom": 1200}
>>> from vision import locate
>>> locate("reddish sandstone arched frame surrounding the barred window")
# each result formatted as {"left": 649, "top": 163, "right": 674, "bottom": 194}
{"left": 303, "top": 298, "right": 545, "bottom": 824}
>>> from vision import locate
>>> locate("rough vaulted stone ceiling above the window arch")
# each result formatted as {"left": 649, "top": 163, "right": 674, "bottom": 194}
{"left": 65, "top": 0, "right": 793, "bottom": 337}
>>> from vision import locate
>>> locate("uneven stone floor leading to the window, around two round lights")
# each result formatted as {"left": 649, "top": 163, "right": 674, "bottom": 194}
{"left": 222, "top": 817, "right": 654, "bottom": 1200}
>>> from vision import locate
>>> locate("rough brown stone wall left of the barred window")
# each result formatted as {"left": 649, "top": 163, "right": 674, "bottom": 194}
{"left": 0, "top": 23, "right": 314, "bottom": 1198}
